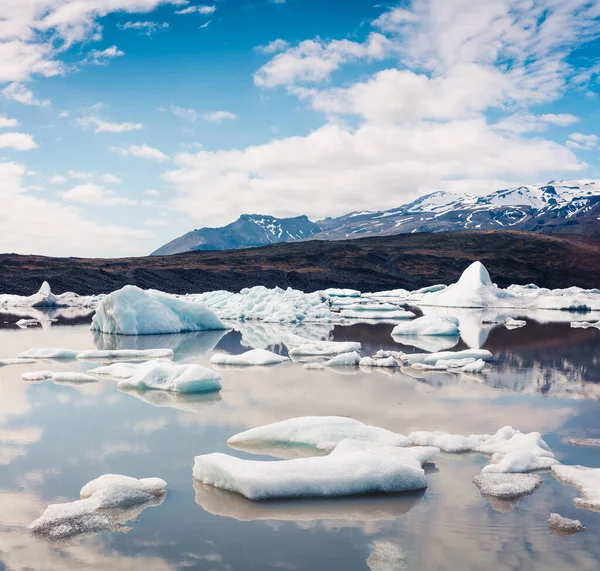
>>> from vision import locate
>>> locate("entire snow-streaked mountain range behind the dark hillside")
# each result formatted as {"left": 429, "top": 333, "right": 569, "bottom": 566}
{"left": 154, "top": 180, "right": 600, "bottom": 254}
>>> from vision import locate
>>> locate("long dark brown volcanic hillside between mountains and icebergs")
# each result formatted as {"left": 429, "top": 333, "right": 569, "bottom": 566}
{"left": 0, "top": 230, "right": 600, "bottom": 295}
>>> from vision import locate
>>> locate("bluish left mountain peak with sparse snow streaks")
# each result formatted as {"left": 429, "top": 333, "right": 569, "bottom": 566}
{"left": 152, "top": 214, "right": 321, "bottom": 256}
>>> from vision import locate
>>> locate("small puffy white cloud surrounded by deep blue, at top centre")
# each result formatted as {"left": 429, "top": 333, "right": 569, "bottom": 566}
{"left": 254, "top": 33, "right": 395, "bottom": 87}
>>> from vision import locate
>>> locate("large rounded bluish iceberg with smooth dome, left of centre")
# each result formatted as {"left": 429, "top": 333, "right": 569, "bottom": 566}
{"left": 92, "top": 286, "right": 227, "bottom": 335}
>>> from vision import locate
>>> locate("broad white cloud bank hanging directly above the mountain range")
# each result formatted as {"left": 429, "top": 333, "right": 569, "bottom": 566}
{"left": 165, "top": 118, "right": 585, "bottom": 224}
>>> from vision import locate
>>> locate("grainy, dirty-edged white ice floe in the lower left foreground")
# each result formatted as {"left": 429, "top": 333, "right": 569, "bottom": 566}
{"left": 29, "top": 474, "right": 167, "bottom": 539}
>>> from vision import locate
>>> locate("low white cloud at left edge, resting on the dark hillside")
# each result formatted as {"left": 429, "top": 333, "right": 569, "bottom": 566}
{"left": 0, "top": 161, "right": 152, "bottom": 256}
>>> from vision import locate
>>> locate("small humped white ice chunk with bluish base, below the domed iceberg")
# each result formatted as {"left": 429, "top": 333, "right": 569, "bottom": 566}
{"left": 118, "top": 361, "right": 221, "bottom": 393}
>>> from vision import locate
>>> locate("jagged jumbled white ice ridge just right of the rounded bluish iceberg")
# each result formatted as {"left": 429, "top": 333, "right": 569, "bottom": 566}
{"left": 190, "top": 286, "right": 332, "bottom": 323}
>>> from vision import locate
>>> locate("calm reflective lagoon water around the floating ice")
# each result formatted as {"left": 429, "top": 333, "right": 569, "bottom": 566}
{"left": 0, "top": 312, "right": 600, "bottom": 571}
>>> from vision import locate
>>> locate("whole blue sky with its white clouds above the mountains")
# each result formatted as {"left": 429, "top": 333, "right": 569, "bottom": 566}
{"left": 0, "top": 0, "right": 600, "bottom": 256}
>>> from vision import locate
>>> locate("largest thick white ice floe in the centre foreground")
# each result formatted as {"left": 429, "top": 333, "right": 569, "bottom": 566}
{"left": 193, "top": 440, "right": 437, "bottom": 500}
